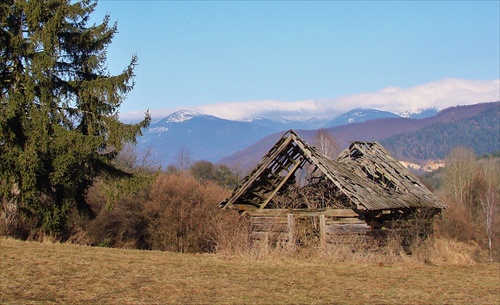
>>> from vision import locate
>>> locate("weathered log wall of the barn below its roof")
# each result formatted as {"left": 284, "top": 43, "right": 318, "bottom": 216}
{"left": 246, "top": 209, "right": 434, "bottom": 248}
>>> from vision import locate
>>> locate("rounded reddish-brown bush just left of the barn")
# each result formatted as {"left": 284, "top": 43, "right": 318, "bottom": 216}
{"left": 144, "top": 173, "right": 227, "bottom": 252}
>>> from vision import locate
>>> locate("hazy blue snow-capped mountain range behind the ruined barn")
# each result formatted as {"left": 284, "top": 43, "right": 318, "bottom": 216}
{"left": 137, "top": 102, "right": 500, "bottom": 170}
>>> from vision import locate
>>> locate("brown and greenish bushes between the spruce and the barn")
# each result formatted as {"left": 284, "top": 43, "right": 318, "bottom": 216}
{"left": 80, "top": 173, "right": 245, "bottom": 252}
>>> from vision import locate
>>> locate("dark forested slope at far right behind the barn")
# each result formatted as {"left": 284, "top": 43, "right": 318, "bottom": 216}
{"left": 380, "top": 103, "right": 500, "bottom": 161}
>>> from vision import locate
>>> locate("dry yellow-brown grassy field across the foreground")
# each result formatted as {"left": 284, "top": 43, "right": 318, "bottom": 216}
{"left": 0, "top": 238, "right": 500, "bottom": 304}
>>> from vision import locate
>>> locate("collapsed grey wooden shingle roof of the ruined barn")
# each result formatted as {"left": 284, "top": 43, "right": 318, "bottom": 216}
{"left": 220, "top": 130, "right": 446, "bottom": 211}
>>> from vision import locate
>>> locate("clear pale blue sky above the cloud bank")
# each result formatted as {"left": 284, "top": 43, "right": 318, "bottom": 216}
{"left": 93, "top": 0, "right": 500, "bottom": 119}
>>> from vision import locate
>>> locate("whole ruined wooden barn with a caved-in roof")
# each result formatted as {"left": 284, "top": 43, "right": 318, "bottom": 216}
{"left": 220, "top": 130, "right": 445, "bottom": 245}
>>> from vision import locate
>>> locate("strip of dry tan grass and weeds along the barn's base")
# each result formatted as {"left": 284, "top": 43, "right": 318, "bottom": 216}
{"left": 218, "top": 215, "right": 480, "bottom": 265}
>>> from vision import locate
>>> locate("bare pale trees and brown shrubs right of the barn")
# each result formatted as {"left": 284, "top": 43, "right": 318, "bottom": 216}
{"left": 420, "top": 146, "right": 500, "bottom": 261}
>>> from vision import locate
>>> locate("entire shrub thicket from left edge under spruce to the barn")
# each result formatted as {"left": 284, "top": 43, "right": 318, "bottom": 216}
{"left": 0, "top": 146, "right": 244, "bottom": 252}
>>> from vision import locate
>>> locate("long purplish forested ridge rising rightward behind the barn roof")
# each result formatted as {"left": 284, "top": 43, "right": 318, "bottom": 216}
{"left": 219, "top": 102, "right": 500, "bottom": 170}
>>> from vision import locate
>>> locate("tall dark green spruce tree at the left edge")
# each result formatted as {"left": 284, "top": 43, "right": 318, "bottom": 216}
{"left": 0, "top": 0, "right": 150, "bottom": 233}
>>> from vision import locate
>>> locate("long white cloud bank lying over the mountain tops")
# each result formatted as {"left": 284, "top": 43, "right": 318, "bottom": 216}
{"left": 121, "top": 79, "right": 500, "bottom": 121}
